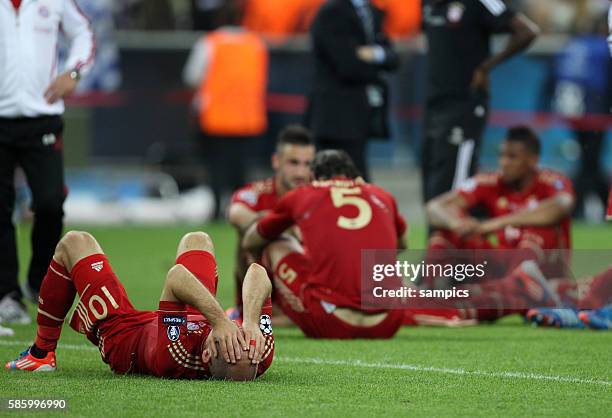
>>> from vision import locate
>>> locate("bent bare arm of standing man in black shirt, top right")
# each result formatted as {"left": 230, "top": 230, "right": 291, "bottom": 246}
{"left": 472, "top": 12, "right": 540, "bottom": 89}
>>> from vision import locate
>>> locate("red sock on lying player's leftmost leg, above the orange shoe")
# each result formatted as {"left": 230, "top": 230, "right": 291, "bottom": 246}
{"left": 35, "top": 260, "right": 76, "bottom": 351}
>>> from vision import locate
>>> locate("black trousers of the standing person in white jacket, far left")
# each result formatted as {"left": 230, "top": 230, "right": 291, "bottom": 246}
{"left": 0, "top": 116, "right": 66, "bottom": 298}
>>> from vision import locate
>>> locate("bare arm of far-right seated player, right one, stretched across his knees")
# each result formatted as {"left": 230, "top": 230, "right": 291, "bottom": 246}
{"left": 480, "top": 193, "right": 575, "bottom": 234}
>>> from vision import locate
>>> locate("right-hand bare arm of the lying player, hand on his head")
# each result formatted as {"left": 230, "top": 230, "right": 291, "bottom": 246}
{"left": 242, "top": 263, "right": 272, "bottom": 363}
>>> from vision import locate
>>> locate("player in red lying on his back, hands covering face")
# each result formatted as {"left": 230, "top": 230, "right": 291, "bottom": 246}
{"left": 6, "top": 232, "right": 274, "bottom": 380}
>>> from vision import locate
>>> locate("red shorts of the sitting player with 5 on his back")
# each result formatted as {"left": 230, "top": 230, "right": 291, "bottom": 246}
{"left": 274, "top": 252, "right": 404, "bottom": 339}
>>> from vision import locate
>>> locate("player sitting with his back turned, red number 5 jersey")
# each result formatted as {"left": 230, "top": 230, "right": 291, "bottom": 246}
{"left": 243, "top": 150, "right": 406, "bottom": 338}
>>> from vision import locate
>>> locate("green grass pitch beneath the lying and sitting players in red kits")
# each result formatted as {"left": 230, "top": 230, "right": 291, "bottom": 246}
{"left": 0, "top": 224, "right": 612, "bottom": 417}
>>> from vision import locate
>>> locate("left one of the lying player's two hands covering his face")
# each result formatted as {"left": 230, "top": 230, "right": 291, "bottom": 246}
{"left": 202, "top": 319, "right": 248, "bottom": 364}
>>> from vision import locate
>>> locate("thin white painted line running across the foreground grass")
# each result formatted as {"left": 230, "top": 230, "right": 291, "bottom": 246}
{"left": 0, "top": 339, "right": 612, "bottom": 386}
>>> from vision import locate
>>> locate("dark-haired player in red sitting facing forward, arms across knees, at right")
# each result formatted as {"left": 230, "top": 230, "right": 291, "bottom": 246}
{"left": 427, "top": 126, "right": 574, "bottom": 320}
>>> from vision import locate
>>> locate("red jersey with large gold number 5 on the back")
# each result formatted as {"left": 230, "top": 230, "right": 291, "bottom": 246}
{"left": 257, "top": 178, "right": 406, "bottom": 308}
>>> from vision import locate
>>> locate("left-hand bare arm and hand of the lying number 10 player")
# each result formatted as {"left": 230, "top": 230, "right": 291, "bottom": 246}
{"left": 160, "top": 264, "right": 248, "bottom": 363}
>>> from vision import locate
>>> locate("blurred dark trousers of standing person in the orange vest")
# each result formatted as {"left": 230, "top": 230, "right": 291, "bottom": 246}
{"left": 198, "top": 134, "right": 251, "bottom": 219}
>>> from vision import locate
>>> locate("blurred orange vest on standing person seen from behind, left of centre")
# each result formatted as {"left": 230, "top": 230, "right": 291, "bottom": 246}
{"left": 198, "top": 30, "right": 268, "bottom": 136}
